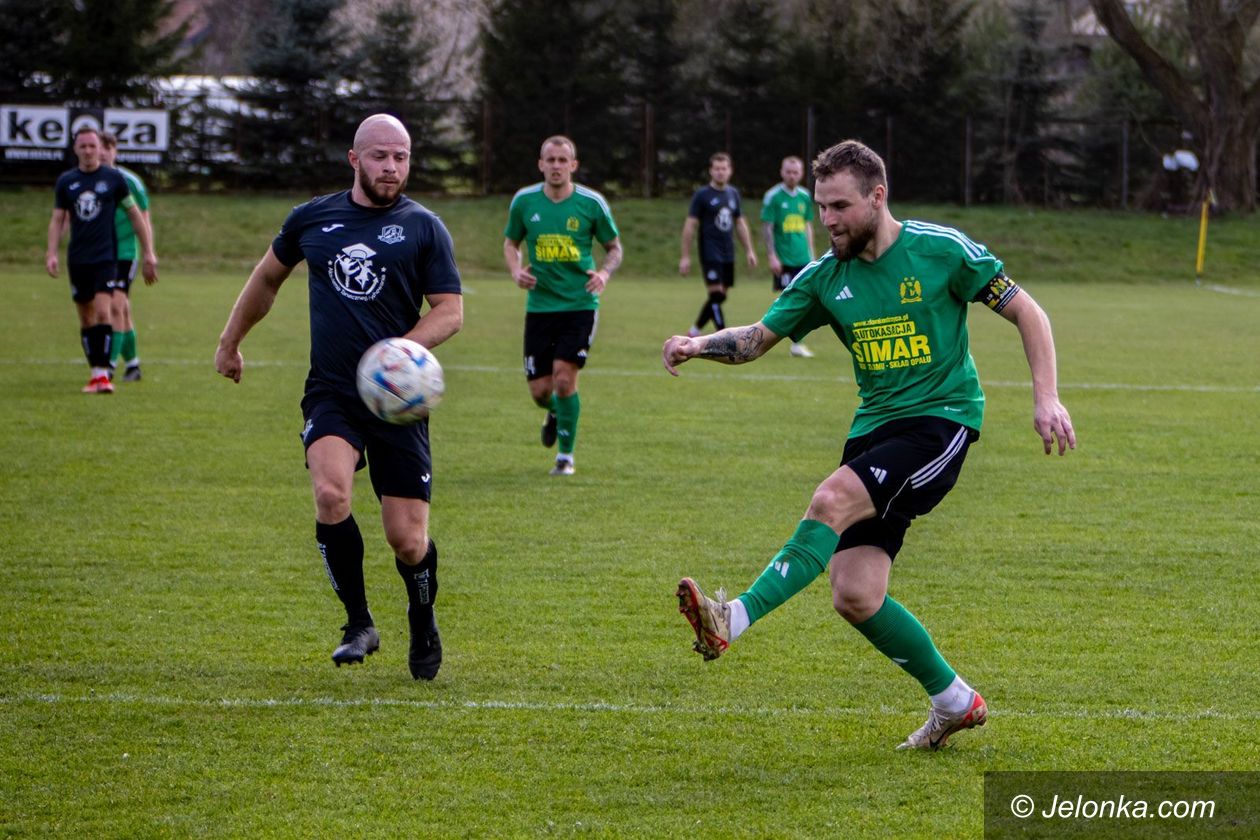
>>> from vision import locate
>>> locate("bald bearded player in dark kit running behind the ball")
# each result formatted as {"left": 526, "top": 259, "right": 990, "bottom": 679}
{"left": 214, "top": 115, "right": 464, "bottom": 680}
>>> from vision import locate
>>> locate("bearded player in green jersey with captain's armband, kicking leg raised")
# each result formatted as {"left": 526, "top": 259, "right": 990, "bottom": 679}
{"left": 662, "top": 140, "right": 1076, "bottom": 749}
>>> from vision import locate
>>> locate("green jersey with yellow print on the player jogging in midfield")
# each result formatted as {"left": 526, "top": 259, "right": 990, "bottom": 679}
{"left": 503, "top": 184, "right": 619, "bottom": 312}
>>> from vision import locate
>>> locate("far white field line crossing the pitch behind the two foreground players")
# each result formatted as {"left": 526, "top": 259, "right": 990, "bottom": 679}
{"left": 0, "top": 358, "right": 1260, "bottom": 394}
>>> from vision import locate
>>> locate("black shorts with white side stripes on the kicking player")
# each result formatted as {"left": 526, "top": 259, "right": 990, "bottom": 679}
{"left": 835, "top": 417, "right": 980, "bottom": 559}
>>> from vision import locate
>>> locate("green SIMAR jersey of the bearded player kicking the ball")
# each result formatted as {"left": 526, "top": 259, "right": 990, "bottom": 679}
{"left": 762, "top": 222, "right": 1002, "bottom": 437}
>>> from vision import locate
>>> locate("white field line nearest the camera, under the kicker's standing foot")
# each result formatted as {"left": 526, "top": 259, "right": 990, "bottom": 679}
{"left": 0, "top": 693, "right": 1260, "bottom": 723}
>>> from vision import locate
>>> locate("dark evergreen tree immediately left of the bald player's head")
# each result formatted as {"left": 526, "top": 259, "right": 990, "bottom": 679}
{"left": 236, "top": 0, "right": 357, "bottom": 188}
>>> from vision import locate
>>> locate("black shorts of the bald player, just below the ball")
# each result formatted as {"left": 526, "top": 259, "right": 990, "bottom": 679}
{"left": 301, "top": 389, "right": 432, "bottom": 501}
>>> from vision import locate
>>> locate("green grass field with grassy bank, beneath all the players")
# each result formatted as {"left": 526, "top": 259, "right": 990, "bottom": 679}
{"left": 0, "top": 187, "right": 1260, "bottom": 837}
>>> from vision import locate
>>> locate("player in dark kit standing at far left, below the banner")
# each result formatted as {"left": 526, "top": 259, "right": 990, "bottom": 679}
{"left": 44, "top": 128, "right": 158, "bottom": 394}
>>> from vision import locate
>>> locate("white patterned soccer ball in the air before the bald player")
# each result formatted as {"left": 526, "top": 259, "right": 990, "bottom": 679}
{"left": 357, "top": 339, "right": 446, "bottom": 426}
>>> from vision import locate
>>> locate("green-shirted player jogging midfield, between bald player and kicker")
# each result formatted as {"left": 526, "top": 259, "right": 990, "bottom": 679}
{"left": 503, "top": 135, "right": 621, "bottom": 476}
